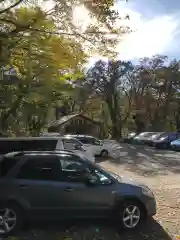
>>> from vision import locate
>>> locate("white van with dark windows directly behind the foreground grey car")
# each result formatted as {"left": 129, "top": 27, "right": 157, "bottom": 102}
{"left": 0, "top": 137, "right": 95, "bottom": 162}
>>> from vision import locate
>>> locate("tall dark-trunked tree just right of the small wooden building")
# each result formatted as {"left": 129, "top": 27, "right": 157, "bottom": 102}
{"left": 86, "top": 60, "right": 132, "bottom": 138}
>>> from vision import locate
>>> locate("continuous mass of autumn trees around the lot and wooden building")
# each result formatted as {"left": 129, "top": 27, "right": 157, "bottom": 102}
{"left": 0, "top": 0, "right": 180, "bottom": 138}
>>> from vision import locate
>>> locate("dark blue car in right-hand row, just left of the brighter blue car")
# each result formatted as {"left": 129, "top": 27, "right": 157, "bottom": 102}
{"left": 153, "top": 133, "right": 180, "bottom": 149}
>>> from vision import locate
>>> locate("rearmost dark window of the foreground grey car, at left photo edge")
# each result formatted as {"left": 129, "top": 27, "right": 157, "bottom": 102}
{"left": 0, "top": 157, "right": 19, "bottom": 177}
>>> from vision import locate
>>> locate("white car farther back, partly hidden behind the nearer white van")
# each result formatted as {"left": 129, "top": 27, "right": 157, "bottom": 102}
{"left": 66, "top": 135, "right": 111, "bottom": 157}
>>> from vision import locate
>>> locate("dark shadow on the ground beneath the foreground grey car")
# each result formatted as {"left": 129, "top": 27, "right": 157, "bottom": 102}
{"left": 15, "top": 220, "right": 173, "bottom": 240}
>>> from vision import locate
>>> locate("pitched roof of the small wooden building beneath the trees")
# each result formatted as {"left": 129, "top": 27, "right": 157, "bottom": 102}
{"left": 47, "top": 113, "right": 100, "bottom": 127}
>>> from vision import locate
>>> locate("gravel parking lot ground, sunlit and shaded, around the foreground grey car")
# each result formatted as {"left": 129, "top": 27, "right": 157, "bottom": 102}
{"left": 9, "top": 144, "right": 180, "bottom": 240}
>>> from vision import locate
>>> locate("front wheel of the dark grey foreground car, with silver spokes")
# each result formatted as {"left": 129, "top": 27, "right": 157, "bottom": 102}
{"left": 116, "top": 200, "right": 146, "bottom": 230}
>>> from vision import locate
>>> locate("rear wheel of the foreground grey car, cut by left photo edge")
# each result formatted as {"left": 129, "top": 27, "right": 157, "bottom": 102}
{"left": 0, "top": 204, "right": 23, "bottom": 237}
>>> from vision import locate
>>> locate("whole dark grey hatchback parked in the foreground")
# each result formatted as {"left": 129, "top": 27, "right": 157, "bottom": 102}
{"left": 0, "top": 151, "right": 156, "bottom": 235}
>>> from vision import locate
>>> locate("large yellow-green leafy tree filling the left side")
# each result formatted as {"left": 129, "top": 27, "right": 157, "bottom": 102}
{"left": 0, "top": 7, "right": 87, "bottom": 136}
